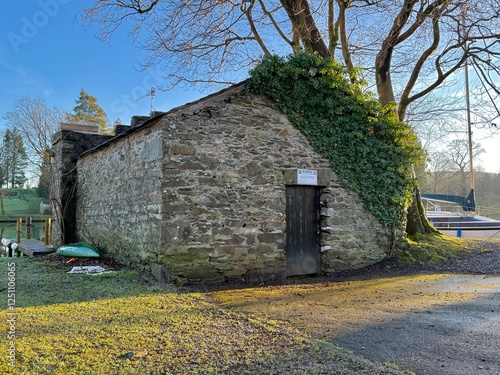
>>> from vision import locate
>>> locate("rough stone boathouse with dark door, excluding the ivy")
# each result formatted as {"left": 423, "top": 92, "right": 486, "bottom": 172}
{"left": 53, "top": 83, "right": 392, "bottom": 283}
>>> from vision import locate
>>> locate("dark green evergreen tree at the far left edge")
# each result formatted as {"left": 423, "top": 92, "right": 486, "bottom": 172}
{"left": 0, "top": 129, "right": 28, "bottom": 188}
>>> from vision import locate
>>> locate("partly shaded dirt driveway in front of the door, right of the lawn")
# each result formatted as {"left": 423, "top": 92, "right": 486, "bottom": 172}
{"left": 211, "top": 250, "right": 500, "bottom": 375}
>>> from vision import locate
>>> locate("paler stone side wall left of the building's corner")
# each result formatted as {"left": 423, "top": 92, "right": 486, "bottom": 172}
{"left": 76, "top": 127, "right": 164, "bottom": 271}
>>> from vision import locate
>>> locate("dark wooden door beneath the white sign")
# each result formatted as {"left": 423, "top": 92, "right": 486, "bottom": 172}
{"left": 285, "top": 186, "right": 320, "bottom": 276}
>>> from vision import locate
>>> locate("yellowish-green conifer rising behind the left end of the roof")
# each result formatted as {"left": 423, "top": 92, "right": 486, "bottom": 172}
{"left": 68, "top": 89, "right": 109, "bottom": 134}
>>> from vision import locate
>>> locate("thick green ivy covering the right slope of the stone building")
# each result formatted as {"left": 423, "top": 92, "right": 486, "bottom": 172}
{"left": 248, "top": 53, "right": 424, "bottom": 227}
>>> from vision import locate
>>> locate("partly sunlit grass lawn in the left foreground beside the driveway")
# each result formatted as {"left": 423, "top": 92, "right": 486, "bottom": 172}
{"left": 0, "top": 258, "right": 406, "bottom": 375}
